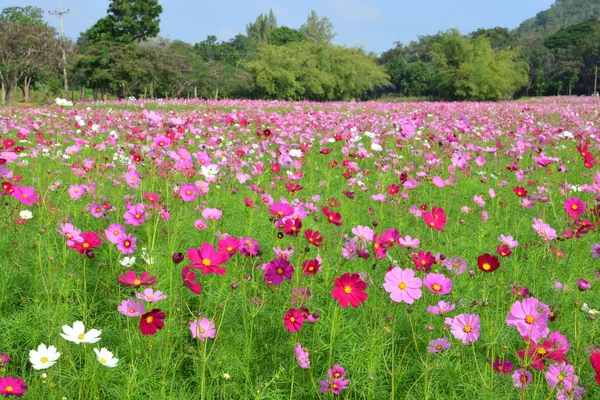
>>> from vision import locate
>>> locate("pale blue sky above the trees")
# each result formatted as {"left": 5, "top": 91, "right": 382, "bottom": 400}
{"left": 5, "top": 0, "right": 554, "bottom": 54}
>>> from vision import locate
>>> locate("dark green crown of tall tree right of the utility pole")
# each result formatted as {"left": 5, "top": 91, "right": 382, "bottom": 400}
{"left": 84, "top": 0, "right": 163, "bottom": 43}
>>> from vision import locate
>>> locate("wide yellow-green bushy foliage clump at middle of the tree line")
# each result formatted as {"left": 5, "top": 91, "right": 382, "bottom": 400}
{"left": 248, "top": 42, "right": 389, "bottom": 100}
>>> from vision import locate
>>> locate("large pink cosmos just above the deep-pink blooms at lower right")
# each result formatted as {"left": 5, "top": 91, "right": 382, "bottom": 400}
{"left": 506, "top": 297, "right": 550, "bottom": 340}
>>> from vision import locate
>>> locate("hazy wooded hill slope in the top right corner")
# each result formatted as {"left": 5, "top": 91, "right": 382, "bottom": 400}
{"left": 515, "top": 0, "right": 600, "bottom": 37}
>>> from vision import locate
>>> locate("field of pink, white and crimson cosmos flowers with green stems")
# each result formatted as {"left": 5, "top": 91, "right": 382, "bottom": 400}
{"left": 0, "top": 98, "right": 600, "bottom": 400}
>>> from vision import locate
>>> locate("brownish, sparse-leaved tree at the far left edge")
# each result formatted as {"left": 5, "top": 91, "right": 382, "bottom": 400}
{"left": 0, "top": 21, "right": 60, "bottom": 105}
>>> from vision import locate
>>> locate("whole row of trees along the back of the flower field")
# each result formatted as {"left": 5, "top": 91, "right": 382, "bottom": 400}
{"left": 0, "top": 0, "right": 600, "bottom": 104}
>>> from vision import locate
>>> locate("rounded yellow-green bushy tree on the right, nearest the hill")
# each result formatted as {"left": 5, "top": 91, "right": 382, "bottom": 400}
{"left": 430, "top": 30, "right": 528, "bottom": 100}
